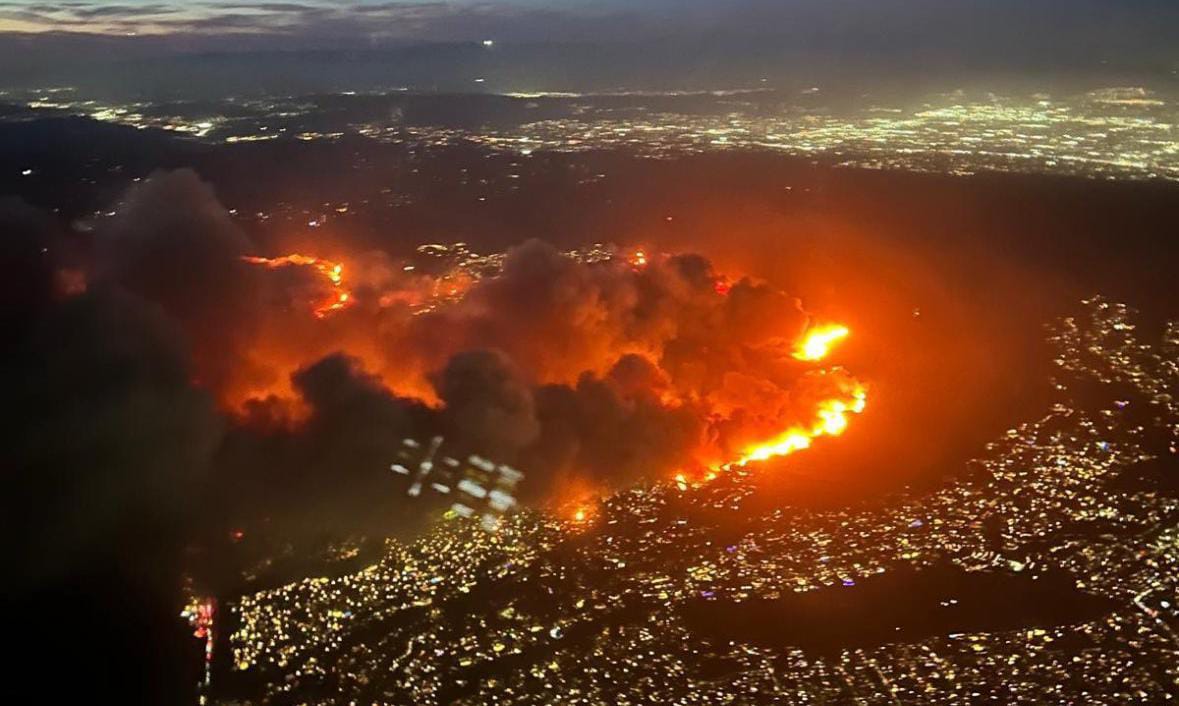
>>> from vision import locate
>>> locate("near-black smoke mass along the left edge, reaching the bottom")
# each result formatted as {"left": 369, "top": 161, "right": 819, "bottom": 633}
{"left": 0, "top": 189, "right": 222, "bottom": 702}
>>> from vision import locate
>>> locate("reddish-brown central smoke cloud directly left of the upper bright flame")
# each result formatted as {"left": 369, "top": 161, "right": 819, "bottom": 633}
{"left": 399, "top": 240, "right": 808, "bottom": 403}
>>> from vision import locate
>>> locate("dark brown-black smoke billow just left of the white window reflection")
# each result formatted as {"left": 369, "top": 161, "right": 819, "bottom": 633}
{"left": 213, "top": 354, "right": 436, "bottom": 547}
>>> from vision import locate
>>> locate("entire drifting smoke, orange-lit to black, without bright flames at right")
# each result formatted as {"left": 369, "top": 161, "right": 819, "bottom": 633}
{"left": 0, "top": 171, "right": 863, "bottom": 558}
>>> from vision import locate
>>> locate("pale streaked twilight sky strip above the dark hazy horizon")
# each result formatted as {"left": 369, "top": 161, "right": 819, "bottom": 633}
{"left": 0, "top": 0, "right": 1179, "bottom": 51}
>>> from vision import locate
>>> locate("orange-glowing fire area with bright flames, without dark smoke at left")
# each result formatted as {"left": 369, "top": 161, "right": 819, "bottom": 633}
{"left": 226, "top": 243, "right": 867, "bottom": 487}
